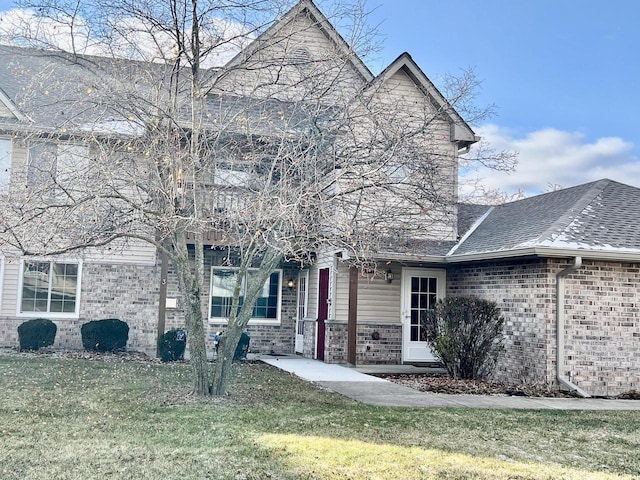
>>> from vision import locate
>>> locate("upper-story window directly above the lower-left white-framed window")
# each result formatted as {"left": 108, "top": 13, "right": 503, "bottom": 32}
{"left": 27, "top": 142, "right": 89, "bottom": 188}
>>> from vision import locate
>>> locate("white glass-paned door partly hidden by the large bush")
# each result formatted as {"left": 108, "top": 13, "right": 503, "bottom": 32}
{"left": 402, "top": 268, "right": 446, "bottom": 362}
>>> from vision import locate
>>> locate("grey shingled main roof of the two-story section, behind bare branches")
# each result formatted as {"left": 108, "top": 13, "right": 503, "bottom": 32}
{"left": 0, "top": 45, "right": 334, "bottom": 135}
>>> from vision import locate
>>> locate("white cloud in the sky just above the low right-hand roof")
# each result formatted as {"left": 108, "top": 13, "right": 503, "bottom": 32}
{"left": 462, "top": 125, "right": 640, "bottom": 201}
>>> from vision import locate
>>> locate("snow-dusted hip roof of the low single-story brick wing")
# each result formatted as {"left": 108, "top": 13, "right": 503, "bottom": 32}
{"left": 448, "top": 179, "right": 640, "bottom": 260}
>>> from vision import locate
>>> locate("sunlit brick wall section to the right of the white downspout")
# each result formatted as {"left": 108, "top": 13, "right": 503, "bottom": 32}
{"left": 564, "top": 261, "right": 640, "bottom": 395}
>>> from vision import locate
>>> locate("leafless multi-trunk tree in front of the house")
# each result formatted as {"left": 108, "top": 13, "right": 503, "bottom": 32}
{"left": 2, "top": 0, "right": 505, "bottom": 395}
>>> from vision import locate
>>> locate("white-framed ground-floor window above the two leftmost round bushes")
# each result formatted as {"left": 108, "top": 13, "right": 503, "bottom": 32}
{"left": 18, "top": 259, "right": 82, "bottom": 318}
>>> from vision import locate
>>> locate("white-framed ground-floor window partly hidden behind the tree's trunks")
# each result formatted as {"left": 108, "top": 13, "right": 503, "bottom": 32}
{"left": 209, "top": 267, "right": 282, "bottom": 323}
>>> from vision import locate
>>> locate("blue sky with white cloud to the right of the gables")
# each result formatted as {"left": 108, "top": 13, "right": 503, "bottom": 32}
{"left": 0, "top": 0, "right": 640, "bottom": 195}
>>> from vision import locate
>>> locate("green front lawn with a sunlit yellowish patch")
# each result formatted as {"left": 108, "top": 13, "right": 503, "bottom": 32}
{"left": 0, "top": 355, "right": 640, "bottom": 480}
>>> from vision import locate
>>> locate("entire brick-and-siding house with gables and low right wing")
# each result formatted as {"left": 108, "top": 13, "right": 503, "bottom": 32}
{"left": 0, "top": 0, "right": 640, "bottom": 395}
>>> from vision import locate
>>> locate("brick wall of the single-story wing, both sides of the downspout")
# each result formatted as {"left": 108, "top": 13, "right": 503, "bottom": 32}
{"left": 447, "top": 259, "right": 640, "bottom": 395}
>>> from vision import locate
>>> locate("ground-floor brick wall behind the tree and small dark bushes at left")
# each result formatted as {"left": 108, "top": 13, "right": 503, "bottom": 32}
{"left": 0, "top": 249, "right": 297, "bottom": 356}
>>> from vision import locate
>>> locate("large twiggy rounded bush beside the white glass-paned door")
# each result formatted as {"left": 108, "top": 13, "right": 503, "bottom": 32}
{"left": 422, "top": 297, "right": 504, "bottom": 380}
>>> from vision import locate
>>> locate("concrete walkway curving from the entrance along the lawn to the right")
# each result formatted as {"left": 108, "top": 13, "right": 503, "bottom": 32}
{"left": 258, "top": 355, "right": 640, "bottom": 410}
